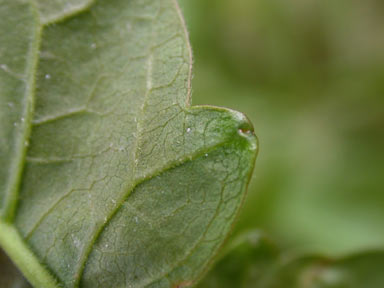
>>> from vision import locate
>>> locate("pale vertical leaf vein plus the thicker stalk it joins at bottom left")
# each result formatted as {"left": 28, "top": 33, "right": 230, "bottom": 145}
{"left": 0, "top": 0, "right": 59, "bottom": 288}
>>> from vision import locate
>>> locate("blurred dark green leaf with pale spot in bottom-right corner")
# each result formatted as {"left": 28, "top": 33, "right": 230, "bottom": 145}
{"left": 264, "top": 251, "right": 384, "bottom": 288}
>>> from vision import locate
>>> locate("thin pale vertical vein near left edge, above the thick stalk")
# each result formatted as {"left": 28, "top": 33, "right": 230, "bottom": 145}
{"left": 3, "top": 1, "right": 42, "bottom": 223}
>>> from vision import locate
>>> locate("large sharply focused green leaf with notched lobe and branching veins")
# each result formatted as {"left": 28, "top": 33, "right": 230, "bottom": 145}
{"left": 0, "top": 0, "right": 257, "bottom": 287}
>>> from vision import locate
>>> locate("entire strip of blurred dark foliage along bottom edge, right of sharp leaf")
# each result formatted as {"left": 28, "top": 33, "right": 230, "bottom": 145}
{"left": 198, "top": 232, "right": 384, "bottom": 288}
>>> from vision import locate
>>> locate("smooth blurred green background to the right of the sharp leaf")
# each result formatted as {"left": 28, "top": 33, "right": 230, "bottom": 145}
{"left": 179, "top": 0, "right": 384, "bottom": 255}
